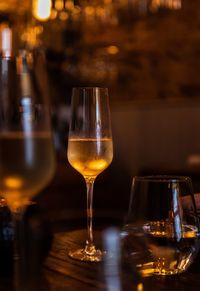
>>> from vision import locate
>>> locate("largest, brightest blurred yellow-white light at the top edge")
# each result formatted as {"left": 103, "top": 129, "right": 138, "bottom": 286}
{"left": 33, "top": 0, "right": 52, "bottom": 21}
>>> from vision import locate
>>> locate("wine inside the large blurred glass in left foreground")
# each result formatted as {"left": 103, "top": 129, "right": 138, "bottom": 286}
{"left": 0, "top": 132, "right": 55, "bottom": 210}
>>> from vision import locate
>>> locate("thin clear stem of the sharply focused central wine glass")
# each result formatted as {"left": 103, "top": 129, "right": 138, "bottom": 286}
{"left": 86, "top": 178, "right": 95, "bottom": 251}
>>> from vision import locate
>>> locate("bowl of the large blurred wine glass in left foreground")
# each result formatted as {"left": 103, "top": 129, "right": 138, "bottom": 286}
{"left": 0, "top": 51, "right": 55, "bottom": 258}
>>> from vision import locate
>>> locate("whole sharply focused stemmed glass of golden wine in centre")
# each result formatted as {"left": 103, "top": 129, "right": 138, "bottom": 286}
{"left": 67, "top": 87, "right": 113, "bottom": 262}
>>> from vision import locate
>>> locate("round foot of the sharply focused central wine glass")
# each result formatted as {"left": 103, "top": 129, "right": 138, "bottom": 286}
{"left": 69, "top": 249, "right": 105, "bottom": 262}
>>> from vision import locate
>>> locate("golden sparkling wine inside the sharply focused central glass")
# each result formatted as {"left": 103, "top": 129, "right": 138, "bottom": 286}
{"left": 68, "top": 138, "right": 113, "bottom": 177}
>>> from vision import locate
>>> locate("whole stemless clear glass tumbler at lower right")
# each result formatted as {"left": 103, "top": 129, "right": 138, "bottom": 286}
{"left": 121, "top": 176, "right": 200, "bottom": 276}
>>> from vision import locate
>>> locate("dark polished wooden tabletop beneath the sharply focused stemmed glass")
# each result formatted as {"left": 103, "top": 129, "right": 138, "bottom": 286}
{"left": 44, "top": 228, "right": 200, "bottom": 291}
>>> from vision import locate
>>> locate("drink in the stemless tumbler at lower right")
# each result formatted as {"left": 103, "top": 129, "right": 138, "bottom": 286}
{"left": 122, "top": 221, "right": 199, "bottom": 276}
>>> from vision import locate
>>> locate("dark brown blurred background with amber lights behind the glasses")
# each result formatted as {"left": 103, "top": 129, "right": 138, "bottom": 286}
{"left": 0, "top": 0, "right": 200, "bottom": 216}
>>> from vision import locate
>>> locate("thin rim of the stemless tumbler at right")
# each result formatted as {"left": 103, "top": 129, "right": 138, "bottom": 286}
{"left": 133, "top": 174, "right": 192, "bottom": 183}
